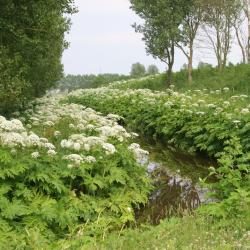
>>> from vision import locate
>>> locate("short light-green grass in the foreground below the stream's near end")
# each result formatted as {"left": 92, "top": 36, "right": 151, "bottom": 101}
{"left": 83, "top": 215, "right": 250, "bottom": 250}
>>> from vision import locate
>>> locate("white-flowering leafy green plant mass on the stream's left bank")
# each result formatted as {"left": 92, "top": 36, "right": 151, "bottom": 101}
{"left": 0, "top": 94, "right": 151, "bottom": 249}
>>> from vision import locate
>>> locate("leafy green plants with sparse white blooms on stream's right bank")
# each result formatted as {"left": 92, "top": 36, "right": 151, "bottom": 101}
{"left": 68, "top": 88, "right": 250, "bottom": 220}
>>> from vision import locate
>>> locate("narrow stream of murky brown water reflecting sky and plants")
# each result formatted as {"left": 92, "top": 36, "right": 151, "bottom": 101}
{"left": 137, "top": 140, "right": 215, "bottom": 224}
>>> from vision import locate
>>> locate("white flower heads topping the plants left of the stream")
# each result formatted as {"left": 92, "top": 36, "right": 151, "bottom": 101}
{"left": 0, "top": 91, "right": 146, "bottom": 167}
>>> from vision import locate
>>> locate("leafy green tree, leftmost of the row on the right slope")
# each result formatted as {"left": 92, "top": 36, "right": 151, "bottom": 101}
{"left": 131, "top": 0, "right": 192, "bottom": 87}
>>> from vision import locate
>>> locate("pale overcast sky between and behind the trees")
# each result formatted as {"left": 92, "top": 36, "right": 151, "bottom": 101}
{"left": 62, "top": 0, "right": 240, "bottom": 74}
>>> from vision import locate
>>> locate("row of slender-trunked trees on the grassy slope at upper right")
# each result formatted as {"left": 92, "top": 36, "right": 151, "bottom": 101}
{"left": 131, "top": 0, "right": 250, "bottom": 85}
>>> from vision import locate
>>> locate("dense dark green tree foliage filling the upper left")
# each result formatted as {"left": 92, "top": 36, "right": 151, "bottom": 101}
{"left": 0, "top": 0, "right": 76, "bottom": 115}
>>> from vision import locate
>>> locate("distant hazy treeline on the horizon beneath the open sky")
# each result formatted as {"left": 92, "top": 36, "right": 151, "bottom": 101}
{"left": 57, "top": 74, "right": 130, "bottom": 91}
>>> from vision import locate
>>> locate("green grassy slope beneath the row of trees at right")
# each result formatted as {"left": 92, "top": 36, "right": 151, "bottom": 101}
{"left": 108, "top": 64, "right": 250, "bottom": 94}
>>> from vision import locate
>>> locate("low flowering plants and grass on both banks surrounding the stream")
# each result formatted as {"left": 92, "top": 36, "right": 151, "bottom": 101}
{"left": 0, "top": 72, "right": 250, "bottom": 249}
